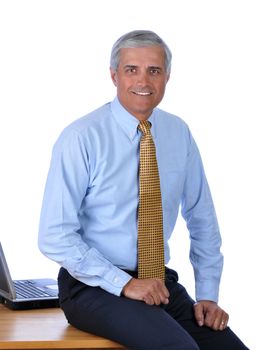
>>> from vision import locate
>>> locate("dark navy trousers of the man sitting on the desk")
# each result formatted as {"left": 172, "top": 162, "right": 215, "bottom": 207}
{"left": 58, "top": 268, "right": 247, "bottom": 350}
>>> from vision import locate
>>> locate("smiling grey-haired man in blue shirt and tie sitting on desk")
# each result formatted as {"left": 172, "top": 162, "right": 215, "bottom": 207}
{"left": 39, "top": 31, "right": 246, "bottom": 350}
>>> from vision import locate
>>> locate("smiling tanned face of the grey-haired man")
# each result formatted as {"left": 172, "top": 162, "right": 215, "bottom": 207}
{"left": 111, "top": 46, "right": 169, "bottom": 120}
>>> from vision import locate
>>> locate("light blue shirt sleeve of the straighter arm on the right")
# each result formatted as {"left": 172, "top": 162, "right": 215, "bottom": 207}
{"left": 181, "top": 133, "right": 223, "bottom": 302}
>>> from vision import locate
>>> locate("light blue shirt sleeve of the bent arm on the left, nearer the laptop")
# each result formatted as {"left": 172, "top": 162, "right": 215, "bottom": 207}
{"left": 38, "top": 130, "right": 131, "bottom": 295}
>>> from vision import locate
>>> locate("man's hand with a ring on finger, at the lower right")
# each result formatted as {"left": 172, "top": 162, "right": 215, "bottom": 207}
{"left": 194, "top": 300, "right": 229, "bottom": 331}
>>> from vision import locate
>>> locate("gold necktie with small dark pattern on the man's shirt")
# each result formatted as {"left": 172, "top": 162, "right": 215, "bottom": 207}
{"left": 138, "top": 121, "right": 165, "bottom": 280}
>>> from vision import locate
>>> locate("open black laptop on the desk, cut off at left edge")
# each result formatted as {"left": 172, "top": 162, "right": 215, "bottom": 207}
{"left": 0, "top": 243, "right": 59, "bottom": 310}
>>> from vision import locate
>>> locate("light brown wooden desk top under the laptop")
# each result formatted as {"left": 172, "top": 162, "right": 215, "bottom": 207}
{"left": 0, "top": 305, "right": 124, "bottom": 349}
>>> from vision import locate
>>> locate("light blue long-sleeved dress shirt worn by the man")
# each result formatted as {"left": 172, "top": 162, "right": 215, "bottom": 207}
{"left": 39, "top": 98, "right": 223, "bottom": 301}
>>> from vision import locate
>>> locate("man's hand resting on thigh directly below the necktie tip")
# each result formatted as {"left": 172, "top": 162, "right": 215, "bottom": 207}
{"left": 122, "top": 278, "right": 170, "bottom": 305}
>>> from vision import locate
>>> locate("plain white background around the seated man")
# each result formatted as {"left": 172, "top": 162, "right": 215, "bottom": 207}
{"left": 0, "top": 0, "right": 278, "bottom": 350}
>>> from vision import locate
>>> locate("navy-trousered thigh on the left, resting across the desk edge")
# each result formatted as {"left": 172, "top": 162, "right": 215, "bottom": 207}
{"left": 58, "top": 269, "right": 199, "bottom": 350}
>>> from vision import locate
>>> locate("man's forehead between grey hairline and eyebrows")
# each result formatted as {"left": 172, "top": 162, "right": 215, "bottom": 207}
{"left": 119, "top": 46, "right": 165, "bottom": 66}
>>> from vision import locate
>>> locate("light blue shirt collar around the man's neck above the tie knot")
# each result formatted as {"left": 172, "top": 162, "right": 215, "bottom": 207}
{"left": 111, "top": 97, "right": 155, "bottom": 141}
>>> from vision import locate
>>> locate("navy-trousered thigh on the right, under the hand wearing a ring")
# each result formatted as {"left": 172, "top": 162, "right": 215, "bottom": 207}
{"left": 165, "top": 271, "right": 250, "bottom": 350}
